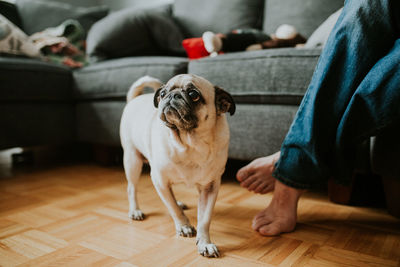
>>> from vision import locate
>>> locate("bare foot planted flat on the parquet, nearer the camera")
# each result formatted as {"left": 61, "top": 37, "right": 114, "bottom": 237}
{"left": 252, "top": 180, "right": 304, "bottom": 236}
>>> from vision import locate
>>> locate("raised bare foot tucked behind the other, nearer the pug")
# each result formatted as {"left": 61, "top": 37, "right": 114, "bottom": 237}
{"left": 236, "top": 151, "right": 281, "bottom": 194}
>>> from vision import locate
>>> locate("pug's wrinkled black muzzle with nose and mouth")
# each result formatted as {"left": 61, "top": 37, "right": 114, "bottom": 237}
{"left": 161, "top": 90, "right": 198, "bottom": 131}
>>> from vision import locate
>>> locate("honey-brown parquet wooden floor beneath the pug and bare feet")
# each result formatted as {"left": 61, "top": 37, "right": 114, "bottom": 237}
{"left": 0, "top": 165, "right": 400, "bottom": 267}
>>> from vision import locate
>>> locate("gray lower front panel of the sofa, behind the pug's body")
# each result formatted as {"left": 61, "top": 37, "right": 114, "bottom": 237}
{"left": 77, "top": 101, "right": 298, "bottom": 156}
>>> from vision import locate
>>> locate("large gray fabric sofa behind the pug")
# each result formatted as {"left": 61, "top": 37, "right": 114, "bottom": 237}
{"left": 0, "top": 0, "right": 398, "bottom": 211}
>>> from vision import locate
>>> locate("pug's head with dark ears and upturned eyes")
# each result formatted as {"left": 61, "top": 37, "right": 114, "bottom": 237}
{"left": 154, "top": 74, "right": 235, "bottom": 132}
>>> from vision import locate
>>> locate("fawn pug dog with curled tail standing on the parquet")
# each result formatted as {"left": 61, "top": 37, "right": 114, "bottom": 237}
{"left": 120, "top": 74, "right": 236, "bottom": 257}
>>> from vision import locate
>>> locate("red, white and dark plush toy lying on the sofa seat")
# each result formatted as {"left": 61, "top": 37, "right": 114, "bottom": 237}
{"left": 182, "top": 24, "right": 306, "bottom": 59}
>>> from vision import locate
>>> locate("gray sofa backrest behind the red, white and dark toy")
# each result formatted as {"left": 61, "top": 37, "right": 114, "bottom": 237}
{"left": 173, "top": 0, "right": 344, "bottom": 37}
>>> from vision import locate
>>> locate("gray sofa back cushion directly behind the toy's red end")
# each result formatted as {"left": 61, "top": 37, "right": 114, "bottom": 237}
{"left": 173, "top": 0, "right": 264, "bottom": 37}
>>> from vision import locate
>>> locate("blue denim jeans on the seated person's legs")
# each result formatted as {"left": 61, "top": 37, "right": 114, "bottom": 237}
{"left": 273, "top": 0, "right": 400, "bottom": 189}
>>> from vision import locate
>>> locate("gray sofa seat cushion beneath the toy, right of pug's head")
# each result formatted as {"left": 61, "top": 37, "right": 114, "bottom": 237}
{"left": 189, "top": 48, "right": 321, "bottom": 105}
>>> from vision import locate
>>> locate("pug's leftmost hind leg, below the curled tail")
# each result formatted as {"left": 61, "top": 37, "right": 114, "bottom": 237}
{"left": 124, "top": 150, "right": 144, "bottom": 220}
